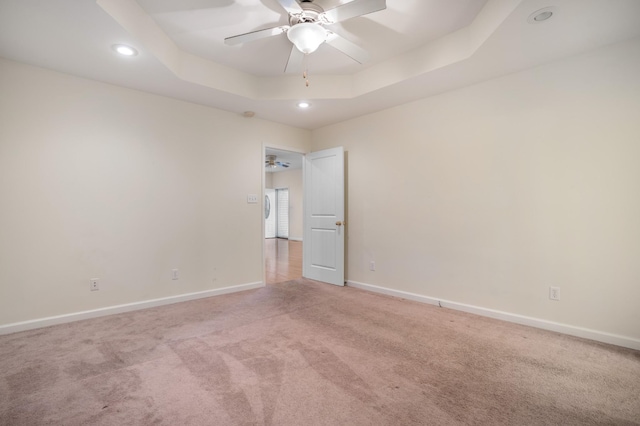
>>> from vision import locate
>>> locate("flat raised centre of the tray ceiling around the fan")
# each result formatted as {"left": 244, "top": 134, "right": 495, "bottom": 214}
{"left": 138, "top": 0, "right": 486, "bottom": 76}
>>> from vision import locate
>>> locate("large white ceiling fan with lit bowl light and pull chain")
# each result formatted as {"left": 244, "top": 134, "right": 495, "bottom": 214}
{"left": 224, "top": 0, "right": 387, "bottom": 73}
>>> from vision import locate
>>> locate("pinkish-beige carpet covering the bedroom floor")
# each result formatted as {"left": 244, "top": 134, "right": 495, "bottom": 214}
{"left": 0, "top": 280, "right": 640, "bottom": 425}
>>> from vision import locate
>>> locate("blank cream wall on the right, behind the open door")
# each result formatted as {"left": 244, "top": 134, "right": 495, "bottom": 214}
{"left": 312, "top": 40, "right": 640, "bottom": 339}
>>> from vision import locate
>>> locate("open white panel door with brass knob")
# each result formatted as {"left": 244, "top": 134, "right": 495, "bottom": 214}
{"left": 302, "top": 147, "right": 345, "bottom": 286}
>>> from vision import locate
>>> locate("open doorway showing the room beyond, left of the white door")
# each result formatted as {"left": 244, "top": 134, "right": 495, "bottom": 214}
{"left": 263, "top": 147, "right": 304, "bottom": 284}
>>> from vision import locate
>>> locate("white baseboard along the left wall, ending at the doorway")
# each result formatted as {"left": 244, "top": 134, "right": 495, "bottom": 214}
{"left": 0, "top": 282, "right": 264, "bottom": 335}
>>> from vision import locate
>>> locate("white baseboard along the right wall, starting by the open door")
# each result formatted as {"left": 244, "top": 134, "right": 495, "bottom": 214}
{"left": 347, "top": 281, "right": 640, "bottom": 350}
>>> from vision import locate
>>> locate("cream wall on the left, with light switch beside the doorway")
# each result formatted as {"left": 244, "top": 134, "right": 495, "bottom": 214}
{"left": 0, "top": 60, "right": 310, "bottom": 325}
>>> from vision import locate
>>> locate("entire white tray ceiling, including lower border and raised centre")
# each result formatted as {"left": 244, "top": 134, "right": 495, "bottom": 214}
{"left": 0, "top": 0, "right": 640, "bottom": 129}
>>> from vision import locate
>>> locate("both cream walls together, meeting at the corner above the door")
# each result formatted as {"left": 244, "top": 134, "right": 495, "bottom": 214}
{"left": 0, "top": 36, "right": 640, "bottom": 339}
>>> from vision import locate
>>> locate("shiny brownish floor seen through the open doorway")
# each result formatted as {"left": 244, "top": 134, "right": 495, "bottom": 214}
{"left": 264, "top": 238, "right": 302, "bottom": 284}
